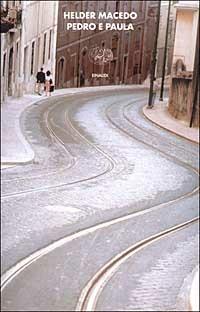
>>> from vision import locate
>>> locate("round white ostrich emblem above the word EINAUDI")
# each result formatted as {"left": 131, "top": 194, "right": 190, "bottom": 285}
{"left": 88, "top": 47, "right": 113, "bottom": 65}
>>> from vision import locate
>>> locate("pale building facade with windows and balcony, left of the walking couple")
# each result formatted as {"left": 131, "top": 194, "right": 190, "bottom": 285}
{"left": 1, "top": 1, "right": 58, "bottom": 100}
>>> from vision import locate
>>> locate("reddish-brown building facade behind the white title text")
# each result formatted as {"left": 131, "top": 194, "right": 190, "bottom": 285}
{"left": 56, "top": 1, "right": 158, "bottom": 88}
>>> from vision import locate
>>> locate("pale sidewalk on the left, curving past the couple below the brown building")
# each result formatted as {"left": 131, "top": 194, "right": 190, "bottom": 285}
{"left": 1, "top": 85, "right": 144, "bottom": 169}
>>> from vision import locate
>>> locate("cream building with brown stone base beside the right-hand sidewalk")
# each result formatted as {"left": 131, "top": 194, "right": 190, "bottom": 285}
{"left": 168, "top": 1, "right": 199, "bottom": 126}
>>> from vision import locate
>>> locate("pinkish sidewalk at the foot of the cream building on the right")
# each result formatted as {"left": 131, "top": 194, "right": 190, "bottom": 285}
{"left": 143, "top": 99, "right": 199, "bottom": 143}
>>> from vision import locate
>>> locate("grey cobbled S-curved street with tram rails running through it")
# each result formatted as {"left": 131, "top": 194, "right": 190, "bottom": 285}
{"left": 2, "top": 90, "right": 198, "bottom": 311}
